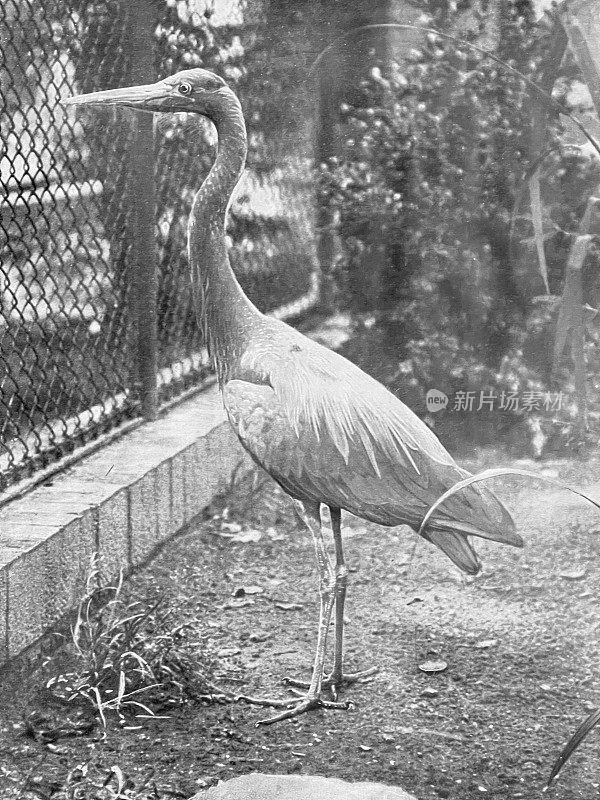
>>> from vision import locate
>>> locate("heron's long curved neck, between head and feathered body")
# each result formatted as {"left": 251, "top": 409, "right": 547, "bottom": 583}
{"left": 188, "top": 92, "right": 261, "bottom": 383}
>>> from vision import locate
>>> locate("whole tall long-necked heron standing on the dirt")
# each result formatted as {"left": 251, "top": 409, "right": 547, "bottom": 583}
{"left": 64, "top": 68, "right": 523, "bottom": 724}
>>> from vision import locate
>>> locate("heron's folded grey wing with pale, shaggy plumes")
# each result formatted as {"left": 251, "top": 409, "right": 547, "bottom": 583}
{"left": 224, "top": 340, "right": 519, "bottom": 557}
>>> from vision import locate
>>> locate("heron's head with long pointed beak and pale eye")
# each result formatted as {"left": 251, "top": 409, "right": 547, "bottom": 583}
{"left": 63, "top": 69, "right": 235, "bottom": 116}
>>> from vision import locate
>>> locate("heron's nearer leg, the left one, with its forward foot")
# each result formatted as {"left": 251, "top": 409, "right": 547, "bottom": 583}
{"left": 254, "top": 500, "right": 348, "bottom": 725}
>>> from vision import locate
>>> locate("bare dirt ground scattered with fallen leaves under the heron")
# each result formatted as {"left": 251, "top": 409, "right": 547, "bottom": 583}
{"left": 0, "top": 454, "right": 600, "bottom": 800}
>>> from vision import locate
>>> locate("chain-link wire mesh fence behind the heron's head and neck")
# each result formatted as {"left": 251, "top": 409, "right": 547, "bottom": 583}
{"left": 0, "top": 0, "right": 316, "bottom": 491}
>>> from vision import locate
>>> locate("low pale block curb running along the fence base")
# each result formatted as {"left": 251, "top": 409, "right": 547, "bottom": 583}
{"left": 0, "top": 388, "right": 252, "bottom": 664}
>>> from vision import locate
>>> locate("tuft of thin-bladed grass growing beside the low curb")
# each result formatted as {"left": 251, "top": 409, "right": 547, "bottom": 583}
{"left": 47, "top": 558, "right": 223, "bottom": 726}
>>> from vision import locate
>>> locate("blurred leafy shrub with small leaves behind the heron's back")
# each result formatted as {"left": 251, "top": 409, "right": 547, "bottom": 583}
{"left": 320, "top": 3, "right": 600, "bottom": 452}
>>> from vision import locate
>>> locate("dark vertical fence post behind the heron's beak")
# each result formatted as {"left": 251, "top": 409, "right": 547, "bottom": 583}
{"left": 129, "top": 0, "right": 158, "bottom": 420}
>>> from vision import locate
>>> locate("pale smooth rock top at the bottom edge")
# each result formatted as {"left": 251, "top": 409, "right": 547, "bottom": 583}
{"left": 191, "top": 772, "right": 416, "bottom": 800}
